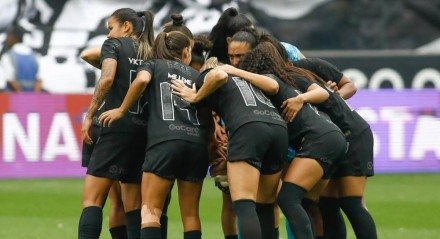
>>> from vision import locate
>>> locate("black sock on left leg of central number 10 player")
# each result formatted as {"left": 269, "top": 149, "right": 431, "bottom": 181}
{"left": 232, "top": 199, "right": 261, "bottom": 239}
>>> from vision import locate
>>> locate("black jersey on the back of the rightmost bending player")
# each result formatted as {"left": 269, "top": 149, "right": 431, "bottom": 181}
{"left": 295, "top": 73, "right": 370, "bottom": 136}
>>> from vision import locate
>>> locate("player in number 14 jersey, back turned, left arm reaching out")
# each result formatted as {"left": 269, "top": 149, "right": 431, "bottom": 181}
{"left": 100, "top": 31, "right": 211, "bottom": 239}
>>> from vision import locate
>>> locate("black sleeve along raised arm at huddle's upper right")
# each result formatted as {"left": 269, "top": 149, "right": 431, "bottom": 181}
{"left": 292, "top": 58, "right": 343, "bottom": 84}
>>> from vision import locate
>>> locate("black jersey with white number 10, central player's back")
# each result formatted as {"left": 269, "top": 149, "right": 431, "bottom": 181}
{"left": 196, "top": 70, "right": 287, "bottom": 137}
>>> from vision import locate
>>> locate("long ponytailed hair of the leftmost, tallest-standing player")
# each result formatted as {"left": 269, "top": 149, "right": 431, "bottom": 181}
{"left": 111, "top": 8, "right": 154, "bottom": 60}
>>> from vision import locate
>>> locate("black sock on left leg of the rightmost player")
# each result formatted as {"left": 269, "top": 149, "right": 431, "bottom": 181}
{"left": 319, "top": 197, "right": 347, "bottom": 239}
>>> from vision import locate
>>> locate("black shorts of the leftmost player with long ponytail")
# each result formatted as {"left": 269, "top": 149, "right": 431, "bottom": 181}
{"left": 87, "top": 132, "right": 147, "bottom": 183}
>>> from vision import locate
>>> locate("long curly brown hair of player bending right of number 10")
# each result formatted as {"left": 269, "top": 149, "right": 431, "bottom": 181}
{"left": 240, "top": 41, "right": 325, "bottom": 89}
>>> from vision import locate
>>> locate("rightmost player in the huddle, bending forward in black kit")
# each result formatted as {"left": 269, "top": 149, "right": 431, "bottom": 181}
{"left": 293, "top": 59, "right": 377, "bottom": 239}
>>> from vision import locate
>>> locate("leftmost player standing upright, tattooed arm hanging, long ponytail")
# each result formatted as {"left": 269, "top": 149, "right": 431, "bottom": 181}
{"left": 78, "top": 8, "right": 153, "bottom": 238}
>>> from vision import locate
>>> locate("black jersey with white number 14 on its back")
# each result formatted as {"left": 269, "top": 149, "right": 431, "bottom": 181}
{"left": 138, "top": 59, "right": 207, "bottom": 148}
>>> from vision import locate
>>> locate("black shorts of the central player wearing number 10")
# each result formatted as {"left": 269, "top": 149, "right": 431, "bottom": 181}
{"left": 228, "top": 122, "right": 288, "bottom": 175}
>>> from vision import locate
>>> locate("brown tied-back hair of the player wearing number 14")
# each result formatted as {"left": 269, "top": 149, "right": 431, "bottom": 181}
{"left": 154, "top": 31, "right": 191, "bottom": 61}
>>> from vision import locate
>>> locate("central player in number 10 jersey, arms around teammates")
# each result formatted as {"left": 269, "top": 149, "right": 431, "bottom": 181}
{"left": 173, "top": 54, "right": 287, "bottom": 239}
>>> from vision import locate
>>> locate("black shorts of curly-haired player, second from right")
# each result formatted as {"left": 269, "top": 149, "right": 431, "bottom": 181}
{"left": 295, "top": 131, "right": 347, "bottom": 179}
